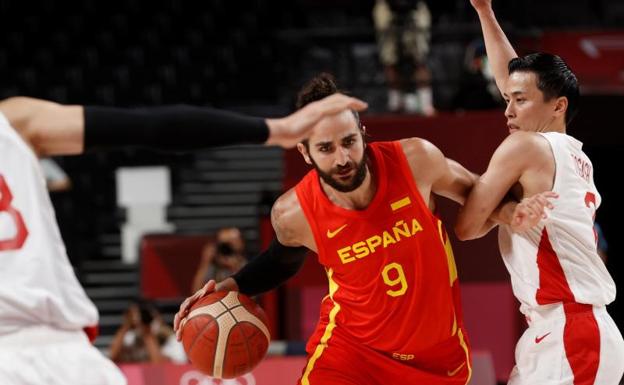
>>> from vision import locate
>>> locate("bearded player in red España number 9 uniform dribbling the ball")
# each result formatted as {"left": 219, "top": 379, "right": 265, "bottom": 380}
{"left": 175, "top": 75, "right": 544, "bottom": 385}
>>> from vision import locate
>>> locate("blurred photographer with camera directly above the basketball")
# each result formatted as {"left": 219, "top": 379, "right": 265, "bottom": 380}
{"left": 192, "top": 227, "right": 247, "bottom": 292}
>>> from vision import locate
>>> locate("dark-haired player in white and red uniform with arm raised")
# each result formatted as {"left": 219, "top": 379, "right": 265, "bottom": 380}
{"left": 456, "top": 0, "right": 624, "bottom": 385}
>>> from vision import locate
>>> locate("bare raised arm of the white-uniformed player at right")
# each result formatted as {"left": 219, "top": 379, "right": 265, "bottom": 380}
{"left": 470, "top": 0, "right": 518, "bottom": 93}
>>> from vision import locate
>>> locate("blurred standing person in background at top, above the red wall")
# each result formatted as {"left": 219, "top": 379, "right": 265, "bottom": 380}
{"left": 373, "top": 0, "right": 435, "bottom": 116}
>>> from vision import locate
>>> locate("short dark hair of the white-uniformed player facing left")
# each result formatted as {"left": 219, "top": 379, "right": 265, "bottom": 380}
{"left": 508, "top": 52, "right": 580, "bottom": 124}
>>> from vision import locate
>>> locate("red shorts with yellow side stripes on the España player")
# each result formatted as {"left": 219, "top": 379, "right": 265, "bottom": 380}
{"left": 298, "top": 329, "right": 471, "bottom": 385}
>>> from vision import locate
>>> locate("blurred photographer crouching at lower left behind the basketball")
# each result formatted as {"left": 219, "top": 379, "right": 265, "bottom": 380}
{"left": 110, "top": 301, "right": 187, "bottom": 363}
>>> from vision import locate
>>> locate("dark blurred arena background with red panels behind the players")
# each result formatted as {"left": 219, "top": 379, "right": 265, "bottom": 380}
{"left": 0, "top": 0, "right": 624, "bottom": 382}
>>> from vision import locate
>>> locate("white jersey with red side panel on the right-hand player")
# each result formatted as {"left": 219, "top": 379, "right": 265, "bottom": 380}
{"left": 499, "top": 132, "right": 615, "bottom": 312}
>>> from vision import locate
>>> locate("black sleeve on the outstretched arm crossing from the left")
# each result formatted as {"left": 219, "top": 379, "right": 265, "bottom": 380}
{"left": 84, "top": 105, "right": 269, "bottom": 151}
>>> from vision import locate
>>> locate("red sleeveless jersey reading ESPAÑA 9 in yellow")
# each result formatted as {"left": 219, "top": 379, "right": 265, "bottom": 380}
{"left": 296, "top": 142, "right": 468, "bottom": 361}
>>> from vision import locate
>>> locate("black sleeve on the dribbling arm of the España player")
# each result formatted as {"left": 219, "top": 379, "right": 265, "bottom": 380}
{"left": 232, "top": 239, "right": 308, "bottom": 295}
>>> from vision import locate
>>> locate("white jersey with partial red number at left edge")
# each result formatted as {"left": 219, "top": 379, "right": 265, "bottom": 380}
{"left": 0, "top": 113, "right": 98, "bottom": 336}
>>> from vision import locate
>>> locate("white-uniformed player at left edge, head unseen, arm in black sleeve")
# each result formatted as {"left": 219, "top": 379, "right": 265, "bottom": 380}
{"left": 0, "top": 95, "right": 366, "bottom": 385}
